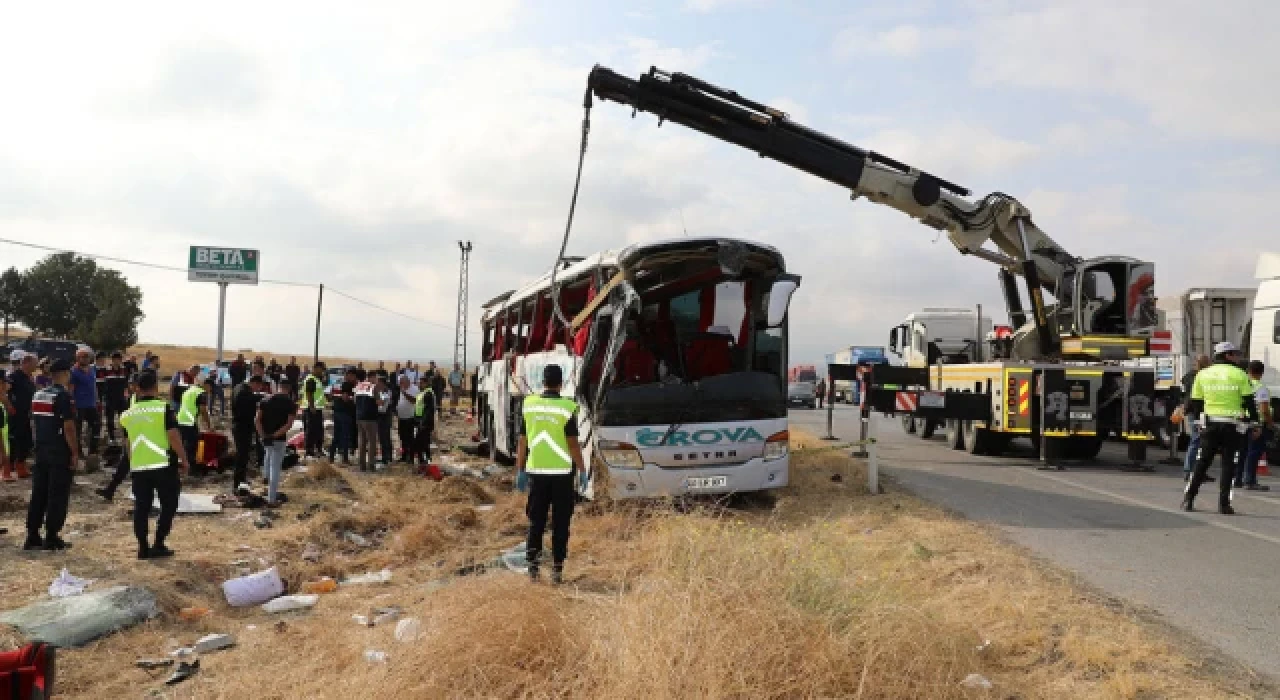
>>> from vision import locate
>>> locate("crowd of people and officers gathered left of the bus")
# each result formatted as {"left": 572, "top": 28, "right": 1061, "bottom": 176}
{"left": 0, "top": 347, "right": 475, "bottom": 558}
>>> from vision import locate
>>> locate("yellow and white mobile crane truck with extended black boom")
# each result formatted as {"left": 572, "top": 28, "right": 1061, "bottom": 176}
{"left": 584, "top": 65, "right": 1161, "bottom": 461}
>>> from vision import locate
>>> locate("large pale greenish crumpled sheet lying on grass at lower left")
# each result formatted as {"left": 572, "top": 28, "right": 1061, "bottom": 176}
{"left": 0, "top": 586, "right": 160, "bottom": 648}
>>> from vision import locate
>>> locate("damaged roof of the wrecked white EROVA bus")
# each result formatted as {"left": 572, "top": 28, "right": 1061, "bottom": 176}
{"left": 483, "top": 238, "right": 786, "bottom": 319}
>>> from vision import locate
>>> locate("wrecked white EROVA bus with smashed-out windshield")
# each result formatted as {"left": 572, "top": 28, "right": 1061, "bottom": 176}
{"left": 479, "top": 238, "right": 800, "bottom": 498}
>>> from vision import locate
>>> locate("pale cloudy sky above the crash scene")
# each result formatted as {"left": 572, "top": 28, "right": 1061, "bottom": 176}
{"left": 0, "top": 0, "right": 1280, "bottom": 361}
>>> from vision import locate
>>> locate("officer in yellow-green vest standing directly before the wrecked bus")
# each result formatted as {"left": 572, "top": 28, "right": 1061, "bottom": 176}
{"left": 516, "top": 365, "right": 584, "bottom": 584}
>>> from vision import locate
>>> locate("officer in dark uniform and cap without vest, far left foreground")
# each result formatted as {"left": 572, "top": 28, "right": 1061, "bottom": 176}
{"left": 22, "top": 360, "right": 79, "bottom": 552}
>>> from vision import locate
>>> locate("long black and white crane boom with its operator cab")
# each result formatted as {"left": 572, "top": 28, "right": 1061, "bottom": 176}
{"left": 585, "top": 65, "right": 1155, "bottom": 357}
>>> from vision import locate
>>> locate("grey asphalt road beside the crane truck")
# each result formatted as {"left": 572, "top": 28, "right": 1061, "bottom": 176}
{"left": 791, "top": 406, "right": 1280, "bottom": 678}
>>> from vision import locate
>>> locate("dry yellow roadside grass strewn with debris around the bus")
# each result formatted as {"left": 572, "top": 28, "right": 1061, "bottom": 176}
{"left": 0, "top": 418, "right": 1274, "bottom": 700}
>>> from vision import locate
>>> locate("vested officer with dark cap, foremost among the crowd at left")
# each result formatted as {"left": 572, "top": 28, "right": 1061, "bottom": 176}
{"left": 120, "top": 371, "right": 190, "bottom": 559}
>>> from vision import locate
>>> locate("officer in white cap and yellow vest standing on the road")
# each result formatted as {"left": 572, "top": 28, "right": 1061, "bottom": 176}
{"left": 1183, "top": 343, "right": 1258, "bottom": 516}
